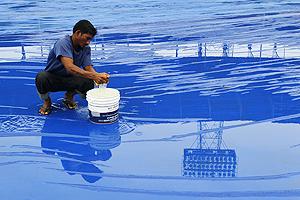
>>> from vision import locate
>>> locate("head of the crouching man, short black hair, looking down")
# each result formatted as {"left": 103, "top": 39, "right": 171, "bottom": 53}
{"left": 73, "top": 20, "right": 97, "bottom": 47}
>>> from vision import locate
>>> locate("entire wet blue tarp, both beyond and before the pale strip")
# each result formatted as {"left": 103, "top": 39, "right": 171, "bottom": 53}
{"left": 0, "top": 1, "right": 300, "bottom": 200}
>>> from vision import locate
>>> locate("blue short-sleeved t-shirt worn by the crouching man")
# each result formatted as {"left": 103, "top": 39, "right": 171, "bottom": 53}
{"left": 45, "top": 35, "right": 93, "bottom": 76}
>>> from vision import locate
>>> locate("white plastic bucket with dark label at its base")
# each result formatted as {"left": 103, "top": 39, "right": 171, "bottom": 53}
{"left": 86, "top": 88, "right": 120, "bottom": 123}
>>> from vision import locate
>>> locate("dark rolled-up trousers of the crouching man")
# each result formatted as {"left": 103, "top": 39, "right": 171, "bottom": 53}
{"left": 35, "top": 71, "right": 94, "bottom": 99}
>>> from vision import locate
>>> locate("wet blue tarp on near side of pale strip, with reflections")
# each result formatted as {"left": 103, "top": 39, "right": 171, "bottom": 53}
{"left": 0, "top": 57, "right": 300, "bottom": 199}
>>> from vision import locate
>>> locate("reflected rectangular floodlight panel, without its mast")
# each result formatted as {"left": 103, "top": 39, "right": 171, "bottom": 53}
{"left": 182, "top": 149, "right": 237, "bottom": 178}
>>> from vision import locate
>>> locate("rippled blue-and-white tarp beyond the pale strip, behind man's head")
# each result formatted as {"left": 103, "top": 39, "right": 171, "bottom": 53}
{"left": 0, "top": 0, "right": 300, "bottom": 58}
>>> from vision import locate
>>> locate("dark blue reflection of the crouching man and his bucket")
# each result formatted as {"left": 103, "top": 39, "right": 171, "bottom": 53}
{"left": 41, "top": 119, "right": 121, "bottom": 183}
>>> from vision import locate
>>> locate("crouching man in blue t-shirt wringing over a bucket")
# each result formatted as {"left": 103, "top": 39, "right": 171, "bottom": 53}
{"left": 35, "top": 20, "right": 109, "bottom": 115}
